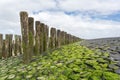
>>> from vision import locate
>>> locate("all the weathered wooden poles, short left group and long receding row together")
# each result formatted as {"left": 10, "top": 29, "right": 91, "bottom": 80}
{"left": 0, "top": 11, "right": 80, "bottom": 63}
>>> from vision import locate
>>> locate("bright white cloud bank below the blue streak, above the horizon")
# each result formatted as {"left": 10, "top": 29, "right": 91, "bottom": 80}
{"left": 34, "top": 11, "right": 120, "bottom": 38}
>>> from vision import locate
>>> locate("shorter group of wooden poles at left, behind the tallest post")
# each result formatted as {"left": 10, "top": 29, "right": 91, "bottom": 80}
{"left": 0, "top": 34, "right": 22, "bottom": 59}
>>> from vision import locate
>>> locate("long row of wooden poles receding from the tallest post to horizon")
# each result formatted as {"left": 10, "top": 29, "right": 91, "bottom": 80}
{"left": 20, "top": 11, "right": 80, "bottom": 63}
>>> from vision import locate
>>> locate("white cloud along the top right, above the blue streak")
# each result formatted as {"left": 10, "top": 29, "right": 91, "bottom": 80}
{"left": 59, "top": 0, "right": 120, "bottom": 14}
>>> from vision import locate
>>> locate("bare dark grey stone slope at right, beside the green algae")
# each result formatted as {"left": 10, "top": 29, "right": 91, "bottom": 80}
{"left": 82, "top": 37, "right": 120, "bottom": 70}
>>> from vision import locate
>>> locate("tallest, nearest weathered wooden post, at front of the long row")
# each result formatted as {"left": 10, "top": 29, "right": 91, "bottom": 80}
{"left": 20, "top": 11, "right": 30, "bottom": 63}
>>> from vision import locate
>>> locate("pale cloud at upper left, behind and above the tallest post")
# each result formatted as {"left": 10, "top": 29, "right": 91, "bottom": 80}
{"left": 0, "top": 0, "right": 56, "bottom": 34}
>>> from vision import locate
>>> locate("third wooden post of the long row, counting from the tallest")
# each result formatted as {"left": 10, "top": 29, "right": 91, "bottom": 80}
{"left": 35, "top": 21, "right": 41, "bottom": 55}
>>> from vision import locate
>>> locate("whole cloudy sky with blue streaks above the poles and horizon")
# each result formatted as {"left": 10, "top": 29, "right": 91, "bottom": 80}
{"left": 0, "top": 0, "right": 120, "bottom": 39}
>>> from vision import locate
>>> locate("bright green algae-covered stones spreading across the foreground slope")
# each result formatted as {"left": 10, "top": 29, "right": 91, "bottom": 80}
{"left": 0, "top": 44, "right": 119, "bottom": 80}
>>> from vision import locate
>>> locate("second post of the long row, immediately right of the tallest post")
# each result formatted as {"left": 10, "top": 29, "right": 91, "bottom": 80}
{"left": 28, "top": 17, "right": 34, "bottom": 58}
